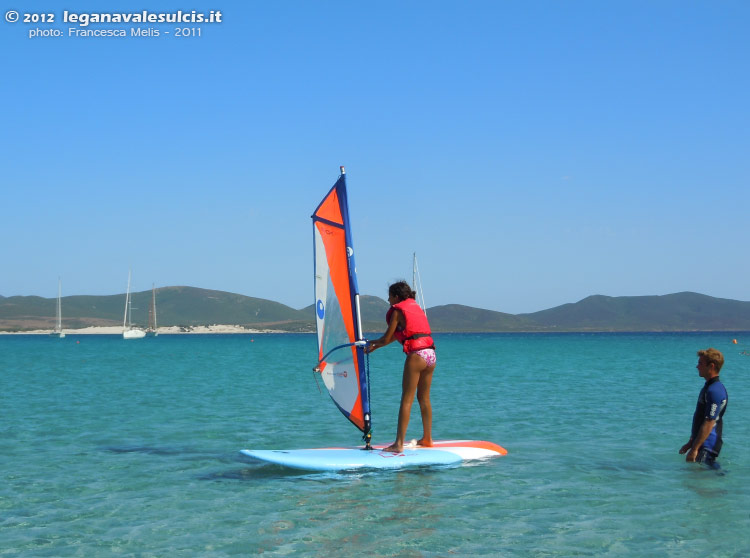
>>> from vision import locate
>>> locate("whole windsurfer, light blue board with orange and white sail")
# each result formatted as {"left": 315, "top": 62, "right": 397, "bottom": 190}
{"left": 241, "top": 167, "right": 507, "bottom": 471}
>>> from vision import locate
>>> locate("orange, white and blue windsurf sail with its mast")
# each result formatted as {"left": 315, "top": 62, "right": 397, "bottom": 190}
{"left": 312, "top": 167, "right": 372, "bottom": 448}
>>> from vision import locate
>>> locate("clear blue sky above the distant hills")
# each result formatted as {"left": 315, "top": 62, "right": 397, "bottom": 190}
{"left": 0, "top": 0, "right": 750, "bottom": 313}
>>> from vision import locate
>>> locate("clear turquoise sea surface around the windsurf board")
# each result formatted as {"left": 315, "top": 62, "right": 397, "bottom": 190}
{"left": 0, "top": 333, "right": 750, "bottom": 558}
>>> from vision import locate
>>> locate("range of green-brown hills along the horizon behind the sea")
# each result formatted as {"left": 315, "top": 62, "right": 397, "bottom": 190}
{"left": 0, "top": 287, "right": 750, "bottom": 332}
